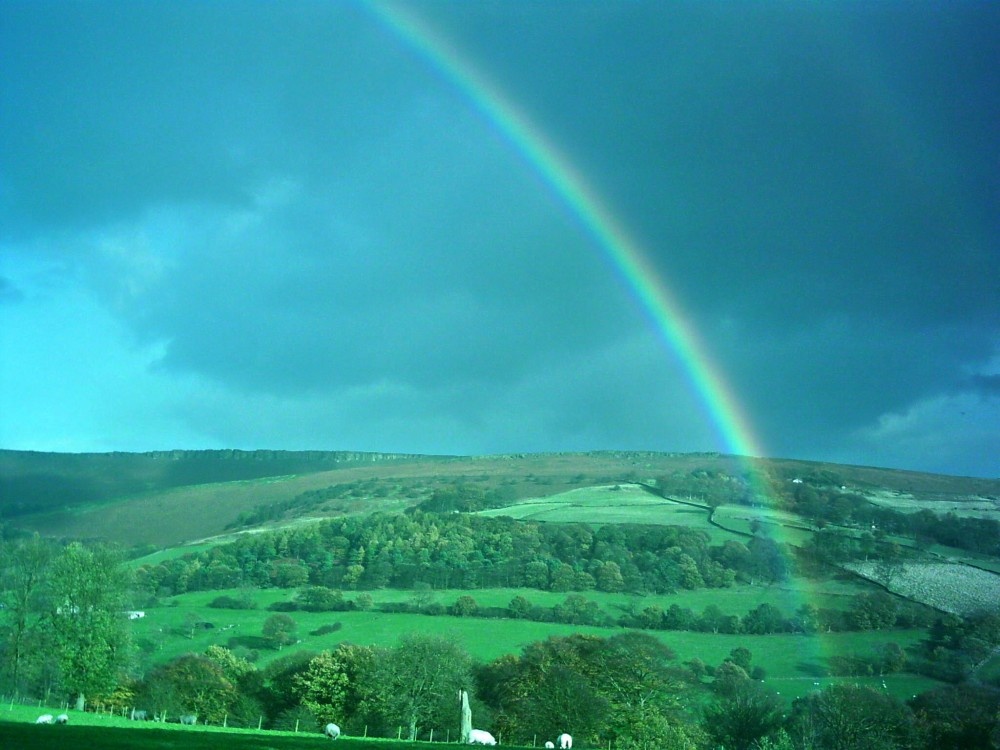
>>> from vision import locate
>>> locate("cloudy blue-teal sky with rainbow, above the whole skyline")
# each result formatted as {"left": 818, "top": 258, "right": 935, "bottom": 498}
{"left": 0, "top": 0, "right": 1000, "bottom": 477}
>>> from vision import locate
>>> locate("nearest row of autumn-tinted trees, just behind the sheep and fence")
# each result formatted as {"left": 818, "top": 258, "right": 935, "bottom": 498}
{"left": 90, "top": 633, "right": 1000, "bottom": 750}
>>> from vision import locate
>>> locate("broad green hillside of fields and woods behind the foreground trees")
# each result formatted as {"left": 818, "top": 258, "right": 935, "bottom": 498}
{"left": 0, "top": 452, "right": 1000, "bottom": 746}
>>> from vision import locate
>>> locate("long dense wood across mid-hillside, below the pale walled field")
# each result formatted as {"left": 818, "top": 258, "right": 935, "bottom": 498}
{"left": 138, "top": 511, "right": 787, "bottom": 595}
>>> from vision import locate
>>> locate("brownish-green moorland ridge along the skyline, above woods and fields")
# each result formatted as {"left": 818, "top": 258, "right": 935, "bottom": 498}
{"left": 0, "top": 450, "right": 1000, "bottom": 547}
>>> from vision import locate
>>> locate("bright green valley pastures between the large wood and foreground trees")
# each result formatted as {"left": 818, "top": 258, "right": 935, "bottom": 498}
{"left": 133, "top": 582, "right": 937, "bottom": 700}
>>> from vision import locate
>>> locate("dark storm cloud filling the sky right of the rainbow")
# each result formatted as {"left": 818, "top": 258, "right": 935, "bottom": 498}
{"left": 418, "top": 3, "right": 1000, "bottom": 452}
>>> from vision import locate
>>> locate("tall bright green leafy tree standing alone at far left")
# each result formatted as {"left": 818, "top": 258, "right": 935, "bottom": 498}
{"left": 49, "top": 542, "right": 131, "bottom": 710}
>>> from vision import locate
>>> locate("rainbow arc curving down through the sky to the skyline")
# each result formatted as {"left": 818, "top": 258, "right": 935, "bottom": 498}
{"left": 367, "top": 2, "right": 766, "bottom": 476}
